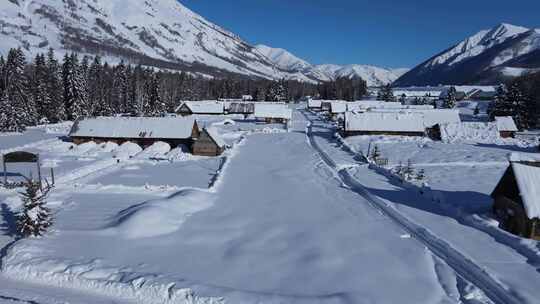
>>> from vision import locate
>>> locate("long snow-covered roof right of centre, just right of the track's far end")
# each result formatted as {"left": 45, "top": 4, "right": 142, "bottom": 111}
{"left": 345, "top": 112, "right": 425, "bottom": 132}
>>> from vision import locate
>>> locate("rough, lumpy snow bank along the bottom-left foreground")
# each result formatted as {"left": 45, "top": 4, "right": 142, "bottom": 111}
{"left": 3, "top": 247, "right": 224, "bottom": 304}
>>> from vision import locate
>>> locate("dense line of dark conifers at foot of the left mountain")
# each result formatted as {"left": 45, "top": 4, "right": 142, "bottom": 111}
{"left": 0, "top": 48, "right": 367, "bottom": 132}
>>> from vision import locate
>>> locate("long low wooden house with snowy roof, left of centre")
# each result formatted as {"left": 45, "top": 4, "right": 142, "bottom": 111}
{"left": 69, "top": 117, "right": 200, "bottom": 148}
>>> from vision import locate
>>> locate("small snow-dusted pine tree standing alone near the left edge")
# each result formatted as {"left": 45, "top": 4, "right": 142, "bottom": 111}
{"left": 17, "top": 179, "right": 52, "bottom": 237}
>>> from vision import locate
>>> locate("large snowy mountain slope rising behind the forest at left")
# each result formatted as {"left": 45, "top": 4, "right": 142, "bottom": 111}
{"left": 0, "top": 0, "right": 316, "bottom": 80}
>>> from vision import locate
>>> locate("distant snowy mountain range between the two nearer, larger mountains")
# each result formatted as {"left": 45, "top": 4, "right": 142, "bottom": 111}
{"left": 256, "top": 45, "right": 408, "bottom": 86}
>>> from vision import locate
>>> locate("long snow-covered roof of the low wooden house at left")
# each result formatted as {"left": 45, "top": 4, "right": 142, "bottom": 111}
{"left": 69, "top": 117, "right": 195, "bottom": 139}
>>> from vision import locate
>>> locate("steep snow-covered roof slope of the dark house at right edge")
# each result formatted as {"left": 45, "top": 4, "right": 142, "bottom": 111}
{"left": 512, "top": 162, "right": 540, "bottom": 219}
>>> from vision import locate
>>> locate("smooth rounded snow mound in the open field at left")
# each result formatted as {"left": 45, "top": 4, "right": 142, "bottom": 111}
{"left": 104, "top": 189, "right": 215, "bottom": 239}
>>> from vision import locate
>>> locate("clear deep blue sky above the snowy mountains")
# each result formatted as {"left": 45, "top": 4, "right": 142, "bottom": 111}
{"left": 180, "top": 0, "right": 540, "bottom": 68}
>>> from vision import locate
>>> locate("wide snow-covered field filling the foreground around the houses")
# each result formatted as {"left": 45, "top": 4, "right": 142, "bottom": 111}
{"left": 0, "top": 110, "right": 540, "bottom": 304}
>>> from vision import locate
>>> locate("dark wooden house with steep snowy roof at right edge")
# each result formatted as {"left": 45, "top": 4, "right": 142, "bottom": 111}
{"left": 491, "top": 154, "right": 540, "bottom": 240}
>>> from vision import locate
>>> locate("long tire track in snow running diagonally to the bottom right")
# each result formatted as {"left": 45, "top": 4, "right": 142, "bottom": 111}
{"left": 300, "top": 111, "right": 523, "bottom": 304}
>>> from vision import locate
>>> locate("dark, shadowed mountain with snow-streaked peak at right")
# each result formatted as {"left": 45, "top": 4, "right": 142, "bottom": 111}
{"left": 395, "top": 23, "right": 540, "bottom": 86}
